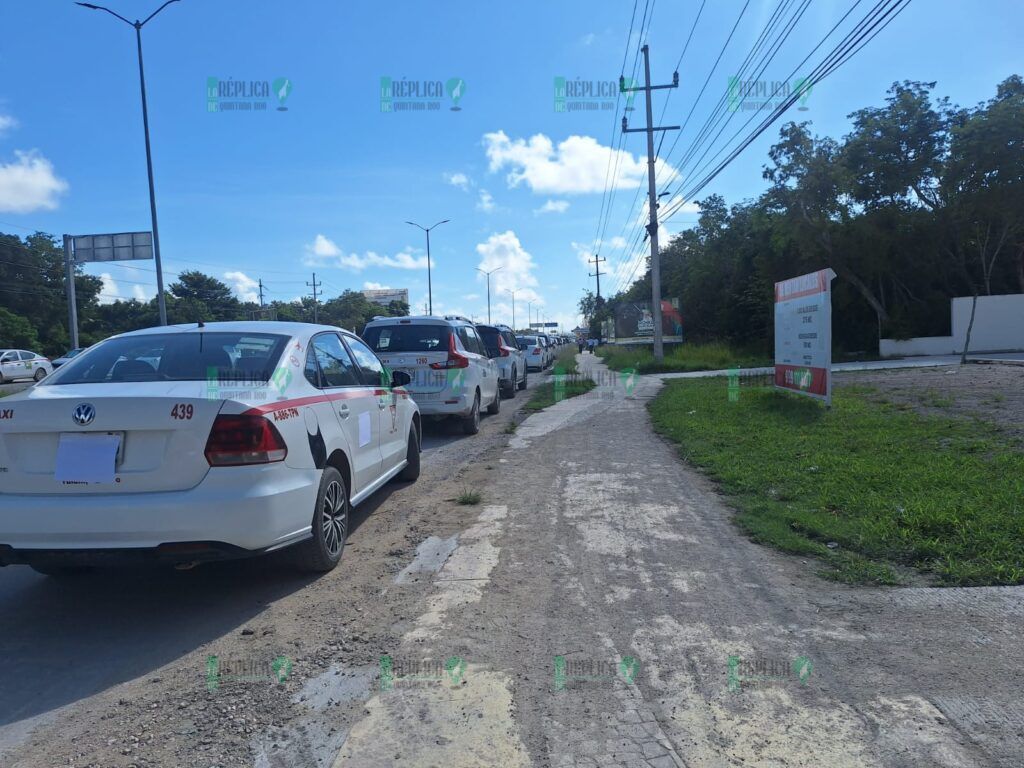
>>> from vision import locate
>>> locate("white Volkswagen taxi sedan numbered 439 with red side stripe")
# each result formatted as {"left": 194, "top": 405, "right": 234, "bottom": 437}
{"left": 0, "top": 322, "right": 421, "bottom": 574}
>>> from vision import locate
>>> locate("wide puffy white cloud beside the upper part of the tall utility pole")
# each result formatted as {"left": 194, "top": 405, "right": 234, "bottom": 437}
{"left": 483, "top": 131, "right": 676, "bottom": 195}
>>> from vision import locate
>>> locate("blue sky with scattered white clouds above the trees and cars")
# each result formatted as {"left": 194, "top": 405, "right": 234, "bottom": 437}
{"left": 0, "top": 0, "right": 1024, "bottom": 330}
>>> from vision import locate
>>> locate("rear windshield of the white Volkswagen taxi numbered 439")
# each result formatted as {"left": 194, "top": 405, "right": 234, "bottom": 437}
{"left": 43, "top": 331, "right": 289, "bottom": 385}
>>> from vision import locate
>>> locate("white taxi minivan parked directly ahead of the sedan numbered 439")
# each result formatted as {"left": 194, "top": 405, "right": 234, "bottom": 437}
{"left": 362, "top": 314, "right": 502, "bottom": 434}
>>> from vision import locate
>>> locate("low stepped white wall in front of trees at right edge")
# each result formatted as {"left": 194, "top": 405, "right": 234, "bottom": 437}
{"left": 879, "top": 294, "right": 1024, "bottom": 357}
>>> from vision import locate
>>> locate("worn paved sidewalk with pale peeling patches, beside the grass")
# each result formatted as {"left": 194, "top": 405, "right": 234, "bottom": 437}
{"left": 336, "top": 355, "right": 1024, "bottom": 768}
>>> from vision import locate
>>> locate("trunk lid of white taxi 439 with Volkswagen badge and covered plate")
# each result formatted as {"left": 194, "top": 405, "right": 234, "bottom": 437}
{"left": 0, "top": 382, "right": 225, "bottom": 494}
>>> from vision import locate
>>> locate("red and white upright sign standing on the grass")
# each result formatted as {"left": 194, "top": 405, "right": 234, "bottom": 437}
{"left": 775, "top": 269, "right": 836, "bottom": 404}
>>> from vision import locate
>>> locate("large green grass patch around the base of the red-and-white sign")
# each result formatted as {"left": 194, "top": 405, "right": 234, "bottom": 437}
{"left": 650, "top": 378, "right": 1024, "bottom": 586}
